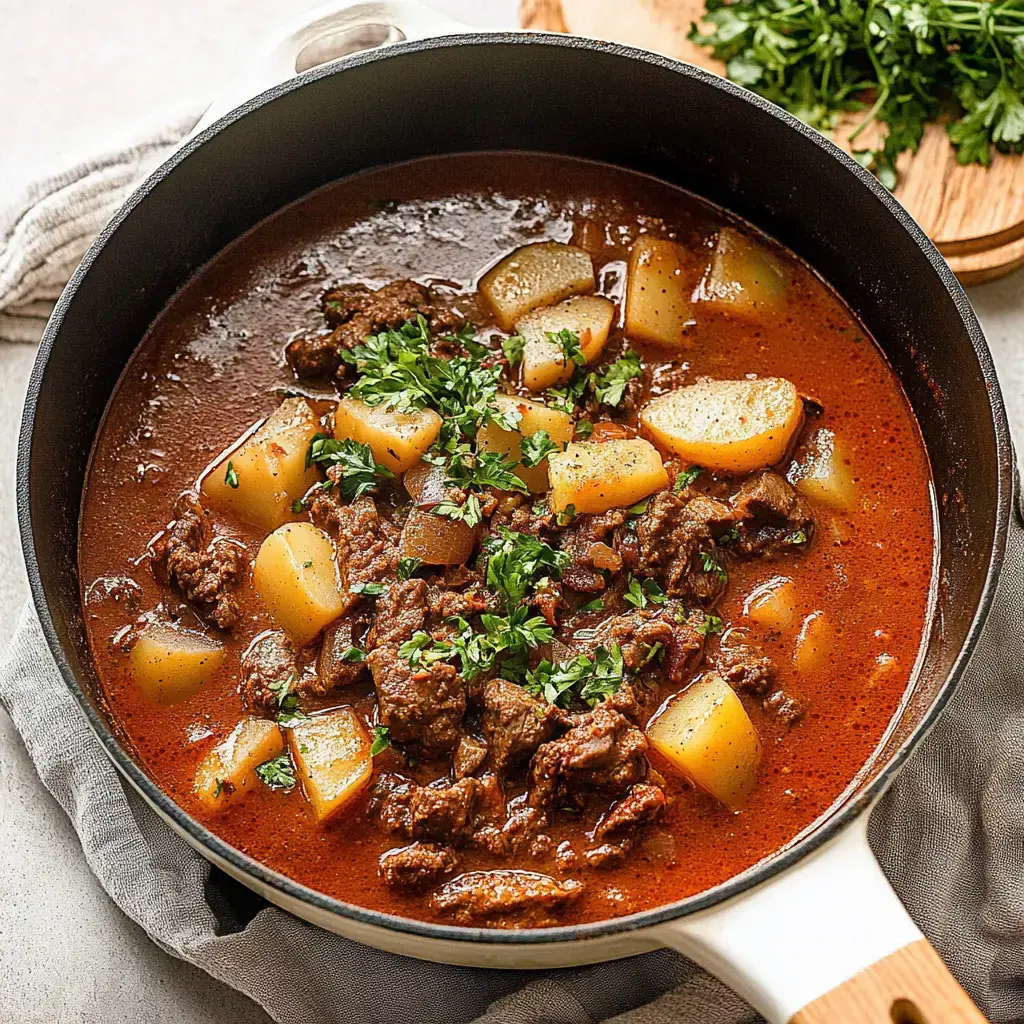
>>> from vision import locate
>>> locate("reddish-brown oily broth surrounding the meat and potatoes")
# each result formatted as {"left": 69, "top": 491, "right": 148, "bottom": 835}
{"left": 80, "top": 154, "right": 933, "bottom": 923}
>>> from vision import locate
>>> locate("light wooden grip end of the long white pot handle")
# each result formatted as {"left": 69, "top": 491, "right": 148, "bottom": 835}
{"left": 790, "top": 939, "right": 985, "bottom": 1024}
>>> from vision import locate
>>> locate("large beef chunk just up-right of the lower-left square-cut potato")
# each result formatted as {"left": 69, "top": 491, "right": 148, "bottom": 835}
{"left": 367, "top": 646, "right": 466, "bottom": 755}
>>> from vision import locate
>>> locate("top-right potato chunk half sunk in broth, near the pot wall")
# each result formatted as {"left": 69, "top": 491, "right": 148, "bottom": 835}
{"left": 697, "top": 227, "right": 785, "bottom": 319}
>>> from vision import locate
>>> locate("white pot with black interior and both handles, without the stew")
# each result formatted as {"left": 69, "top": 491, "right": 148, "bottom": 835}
{"left": 18, "top": 2, "right": 1013, "bottom": 1024}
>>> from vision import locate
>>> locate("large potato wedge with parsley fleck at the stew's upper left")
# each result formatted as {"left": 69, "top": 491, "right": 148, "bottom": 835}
{"left": 203, "top": 398, "right": 319, "bottom": 529}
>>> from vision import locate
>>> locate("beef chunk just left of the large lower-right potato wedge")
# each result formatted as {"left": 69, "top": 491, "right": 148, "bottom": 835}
{"left": 528, "top": 705, "right": 647, "bottom": 811}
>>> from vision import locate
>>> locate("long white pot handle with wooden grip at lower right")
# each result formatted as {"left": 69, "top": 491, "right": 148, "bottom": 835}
{"left": 655, "top": 813, "right": 985, "bottom": 1024}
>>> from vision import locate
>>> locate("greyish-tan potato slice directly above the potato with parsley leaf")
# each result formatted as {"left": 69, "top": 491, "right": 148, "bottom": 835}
{"left": 479, "top": 242, "right": 594, "bottom": 331}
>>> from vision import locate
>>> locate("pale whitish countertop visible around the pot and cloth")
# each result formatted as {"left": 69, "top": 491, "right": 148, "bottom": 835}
{"left": 0, "top": 0, "right": 1024, "bottom": 1024}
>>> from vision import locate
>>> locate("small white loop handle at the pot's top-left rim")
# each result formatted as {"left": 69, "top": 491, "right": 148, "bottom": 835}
{"left": 186, "top": 0, "right": 474, "bottom": 140}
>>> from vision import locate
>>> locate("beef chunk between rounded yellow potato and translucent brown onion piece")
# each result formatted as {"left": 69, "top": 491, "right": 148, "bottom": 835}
{"left": 309, "top": 488, "right": 399, "bottom": 587}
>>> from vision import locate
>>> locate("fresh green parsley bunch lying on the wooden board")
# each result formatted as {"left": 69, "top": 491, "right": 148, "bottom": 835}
{"left": 689, "top": 0, "right": 1024, "bottom": 188}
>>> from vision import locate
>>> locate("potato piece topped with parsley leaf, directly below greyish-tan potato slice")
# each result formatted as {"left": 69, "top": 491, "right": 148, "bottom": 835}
{"left": 515, "top": 295, "right": 615, "bottom": 391}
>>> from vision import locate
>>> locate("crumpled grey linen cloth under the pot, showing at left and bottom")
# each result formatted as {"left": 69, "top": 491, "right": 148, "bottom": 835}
{"left": 0, "top": 119, "right": 1024, "bottom": 1024}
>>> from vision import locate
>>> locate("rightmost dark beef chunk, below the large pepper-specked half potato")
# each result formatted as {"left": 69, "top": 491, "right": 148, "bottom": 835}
{"left": 729, "top": 469, "right": 814, "bottom": 558}
